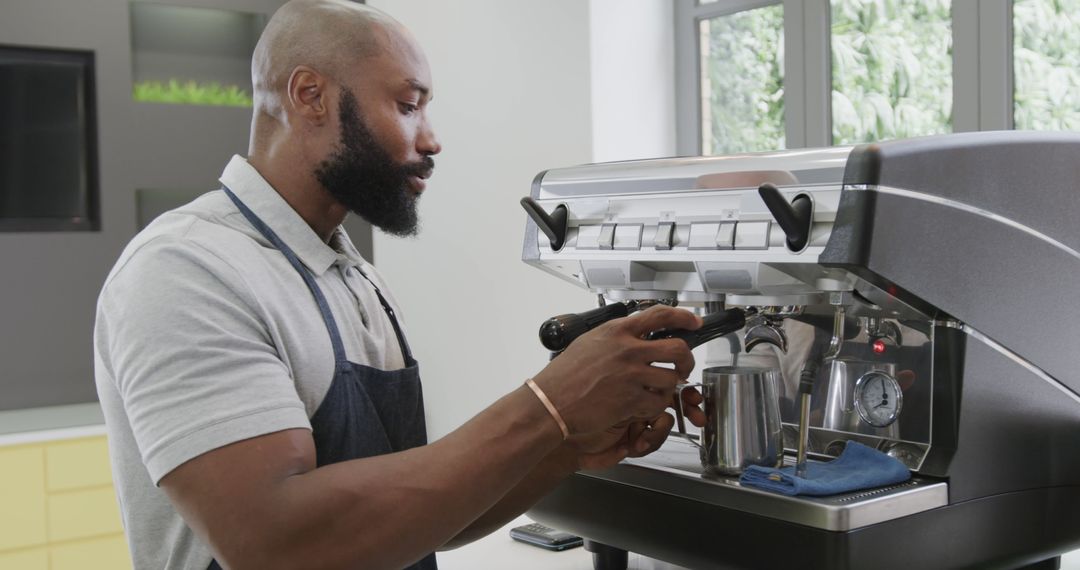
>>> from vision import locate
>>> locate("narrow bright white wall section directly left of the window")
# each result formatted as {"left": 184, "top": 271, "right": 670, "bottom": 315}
{"left": 589, "top": 0, "right": 675, "bottom": 162}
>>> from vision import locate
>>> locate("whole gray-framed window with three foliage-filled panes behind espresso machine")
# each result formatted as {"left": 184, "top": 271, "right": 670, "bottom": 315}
{"left": 675, "top": 0, "right": 1080, "bottom": 154}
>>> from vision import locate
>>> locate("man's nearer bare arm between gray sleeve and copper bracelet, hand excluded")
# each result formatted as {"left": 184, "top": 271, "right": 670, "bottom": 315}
{"left": 163, "top": 389, "right": 559, "bottom": 569}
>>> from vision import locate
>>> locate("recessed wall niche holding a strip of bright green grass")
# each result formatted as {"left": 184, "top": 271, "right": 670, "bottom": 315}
{"left": 129, "top": 2, "right": 267, "bottom": 107}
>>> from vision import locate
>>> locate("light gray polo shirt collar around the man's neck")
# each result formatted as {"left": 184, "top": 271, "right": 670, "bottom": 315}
{"left": 220, "top": 155, "right": 339, "bottom": 275}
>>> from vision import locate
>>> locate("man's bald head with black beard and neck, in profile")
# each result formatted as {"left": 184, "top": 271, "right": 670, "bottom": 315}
{"left": 247, "top": 0, "right": 441, "bottom": 240}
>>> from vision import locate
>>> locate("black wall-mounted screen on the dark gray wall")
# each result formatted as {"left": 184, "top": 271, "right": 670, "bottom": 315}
{"left": 0, "top": 45, "right": 99, "bottom": 231}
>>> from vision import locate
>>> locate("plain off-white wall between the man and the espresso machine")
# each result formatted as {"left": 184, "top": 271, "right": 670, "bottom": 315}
{"left": 368, "top": 0, "right": 595, "bottom": 439}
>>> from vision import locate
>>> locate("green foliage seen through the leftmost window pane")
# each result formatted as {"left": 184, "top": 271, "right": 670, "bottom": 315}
{"left": 701, "top": 4, "right": 784, "bottom": 154}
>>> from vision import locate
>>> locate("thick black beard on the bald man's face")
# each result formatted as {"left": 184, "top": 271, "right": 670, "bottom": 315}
{"left": 314, "top": 87, "right": 435, "bottom": 236}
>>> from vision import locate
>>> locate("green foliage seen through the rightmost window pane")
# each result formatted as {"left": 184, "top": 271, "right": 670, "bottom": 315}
{"left": 1013, "top": 0, "right": 1080, "bottom": 131}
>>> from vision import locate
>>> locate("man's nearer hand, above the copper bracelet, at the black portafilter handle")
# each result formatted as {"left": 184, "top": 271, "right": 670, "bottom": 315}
{"left": 534, "top": 306, "right": 701, "bottom": 434}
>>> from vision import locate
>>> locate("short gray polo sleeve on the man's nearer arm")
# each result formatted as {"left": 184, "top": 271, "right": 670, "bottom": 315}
{"left": 95, "top": 236, "right": 311, "bottom": 485}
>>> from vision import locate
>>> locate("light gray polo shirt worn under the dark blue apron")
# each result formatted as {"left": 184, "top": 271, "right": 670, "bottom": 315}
{"left": 94, "top": 157, "right": 404, "bottom": 570}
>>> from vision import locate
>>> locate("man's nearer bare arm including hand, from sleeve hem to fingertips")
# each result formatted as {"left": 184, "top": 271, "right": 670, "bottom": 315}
{"left": 161, "top": 308, "right": 700, "bottom": 569}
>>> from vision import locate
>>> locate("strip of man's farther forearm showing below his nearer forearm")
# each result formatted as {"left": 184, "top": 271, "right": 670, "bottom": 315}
{"left": 440, "top": 445, "right": 578, "bottom": 551}
